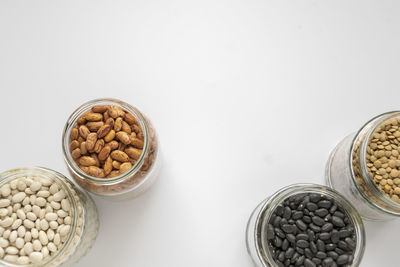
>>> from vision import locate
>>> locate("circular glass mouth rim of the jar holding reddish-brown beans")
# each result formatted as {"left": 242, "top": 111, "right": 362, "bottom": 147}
{"left": 62, "top": 98, "right": 150, "bottom": 187}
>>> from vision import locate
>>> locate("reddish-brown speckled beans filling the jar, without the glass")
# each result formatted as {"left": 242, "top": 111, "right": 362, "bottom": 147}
{"left": 70, "top": 105, "right": 144, "bottom": 178}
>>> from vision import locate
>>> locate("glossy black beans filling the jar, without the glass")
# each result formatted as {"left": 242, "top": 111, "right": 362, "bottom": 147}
{"left": 266, "top": 193, "right": 357, "bottom": 267}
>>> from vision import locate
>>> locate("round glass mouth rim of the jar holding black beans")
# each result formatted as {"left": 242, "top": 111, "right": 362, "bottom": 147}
{"left": 254, "top": 183, "right": 365, "bottom": 266}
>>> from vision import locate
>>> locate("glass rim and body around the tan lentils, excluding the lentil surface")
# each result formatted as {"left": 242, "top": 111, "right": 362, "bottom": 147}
{"left": 325, "top": 111, "right": 400, "bottom": 221}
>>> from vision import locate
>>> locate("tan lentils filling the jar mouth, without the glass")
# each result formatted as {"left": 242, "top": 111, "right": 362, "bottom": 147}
{"left": 366, "top": 119, "right": 400, "bottom": 202}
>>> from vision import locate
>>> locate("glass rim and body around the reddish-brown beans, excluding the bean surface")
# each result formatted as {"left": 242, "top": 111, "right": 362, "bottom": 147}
{"left": 62, "top": 99, "right": 160, "bottom": 200}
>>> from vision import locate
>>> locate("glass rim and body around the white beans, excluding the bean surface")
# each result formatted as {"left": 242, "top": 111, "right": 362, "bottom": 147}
{"left": 0, "top": 167, "right": 99, "bottom": 267}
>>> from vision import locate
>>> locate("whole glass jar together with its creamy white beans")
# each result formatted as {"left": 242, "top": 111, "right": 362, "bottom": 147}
{"left": 0, "top": 167, "right": 99, "bottom": 267}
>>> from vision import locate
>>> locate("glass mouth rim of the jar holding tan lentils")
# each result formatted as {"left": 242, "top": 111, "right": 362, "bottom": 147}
{"left": 349, "top": 111, "right": 400, "bottom": 216}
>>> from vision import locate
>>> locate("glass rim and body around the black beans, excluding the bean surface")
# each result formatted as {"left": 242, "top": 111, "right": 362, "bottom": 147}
{"left": 246, "top": 184, "right": 365, "bottom": 267}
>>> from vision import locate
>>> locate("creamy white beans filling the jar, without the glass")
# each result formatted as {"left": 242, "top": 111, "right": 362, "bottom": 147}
{"left": 0, "top": 177, "right": 73, "bottom": 265}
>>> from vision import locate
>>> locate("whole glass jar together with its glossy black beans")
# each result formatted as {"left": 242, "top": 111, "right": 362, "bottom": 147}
{"left": 246, "top": 184, "right": 365, "bottom": 267}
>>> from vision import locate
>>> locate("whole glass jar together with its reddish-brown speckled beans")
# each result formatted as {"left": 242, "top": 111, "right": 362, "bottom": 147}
{"left": 62, "top": 99, "right": 160, "bottom": 200}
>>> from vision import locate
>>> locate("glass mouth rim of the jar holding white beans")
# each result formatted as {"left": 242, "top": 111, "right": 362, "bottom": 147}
{"left": 0, "top": 167, "right": 79, "bottom": 267}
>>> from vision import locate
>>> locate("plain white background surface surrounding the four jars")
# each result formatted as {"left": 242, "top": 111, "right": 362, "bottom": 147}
{"left": 0, "top": 0, "right": 400, "bottom": 267}
